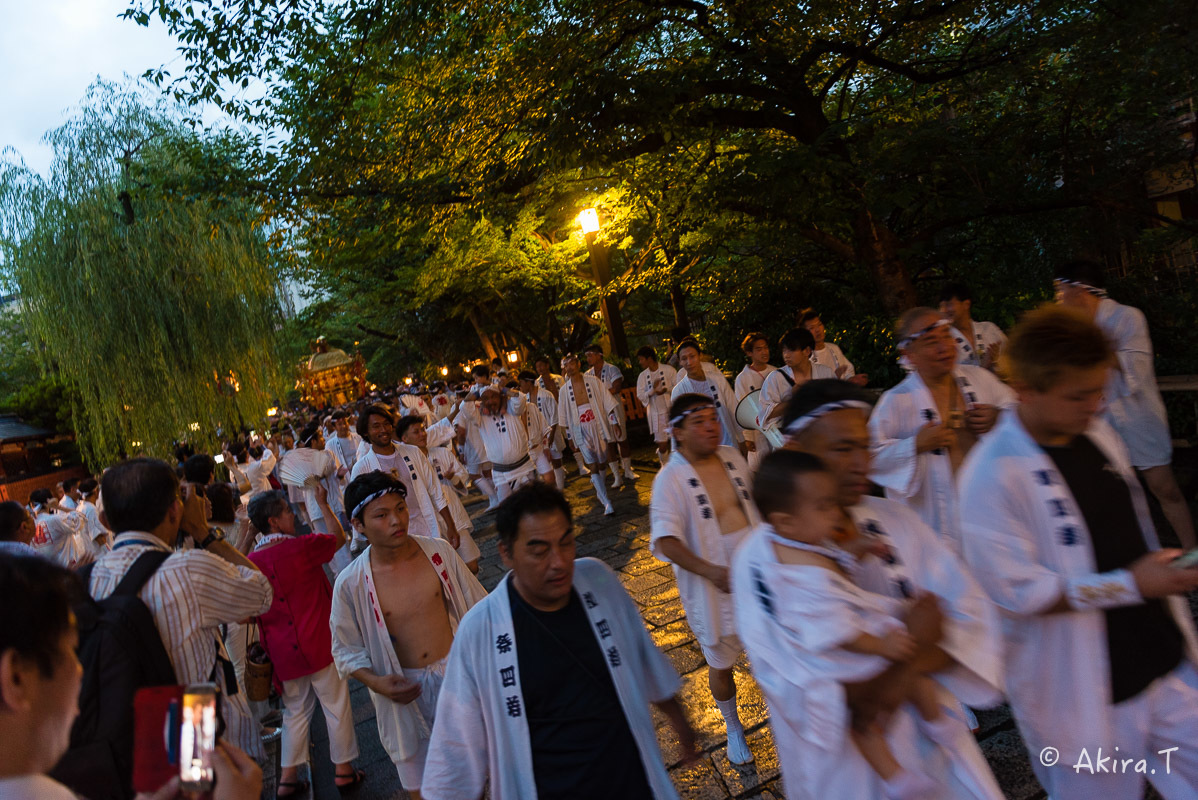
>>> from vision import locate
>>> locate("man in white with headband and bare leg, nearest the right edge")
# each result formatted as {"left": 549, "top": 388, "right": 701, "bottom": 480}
{"left": 1055, "top": 261, "right": 1198, "bottom": 547}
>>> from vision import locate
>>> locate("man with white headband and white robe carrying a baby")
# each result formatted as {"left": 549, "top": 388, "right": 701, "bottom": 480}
{"left": 732, "top": 380, "right": 1003, "bottom": 800}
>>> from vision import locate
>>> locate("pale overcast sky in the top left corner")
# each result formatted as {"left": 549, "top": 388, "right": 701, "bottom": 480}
{"left": 0, "top": 0, "right": 194, "bottom": 175}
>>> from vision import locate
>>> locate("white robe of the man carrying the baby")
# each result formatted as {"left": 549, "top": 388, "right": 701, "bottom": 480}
{"left": 732, "top": 497, "right": 1003, "bottom": 800}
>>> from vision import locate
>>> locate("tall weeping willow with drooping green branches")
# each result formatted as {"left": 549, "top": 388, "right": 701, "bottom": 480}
{"left": 0, "top": 84, "right": 283, "bottom": 466}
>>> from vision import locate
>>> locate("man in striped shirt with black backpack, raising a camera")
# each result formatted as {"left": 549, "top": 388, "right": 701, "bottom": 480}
{"left": 89, "top": 459, "right": 274, "bottom": 760}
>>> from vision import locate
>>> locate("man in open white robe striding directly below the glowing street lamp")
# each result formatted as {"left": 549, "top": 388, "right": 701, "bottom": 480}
{"left": 557, "top": 353, "right": 623, "bottom": 516}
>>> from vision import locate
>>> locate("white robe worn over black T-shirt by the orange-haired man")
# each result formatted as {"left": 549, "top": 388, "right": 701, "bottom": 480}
{"left": 960, "top": 408, "right": 1198, "bottom": 786}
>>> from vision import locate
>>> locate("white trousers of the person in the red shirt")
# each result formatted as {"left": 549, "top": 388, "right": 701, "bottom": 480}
{"left": 282, "top": 663, "right": 358, "bottom": 766}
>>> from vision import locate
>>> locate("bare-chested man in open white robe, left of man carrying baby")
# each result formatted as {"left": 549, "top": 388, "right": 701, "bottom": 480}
{"left": 649, "top": 394, "right": 760, "bottom": 764}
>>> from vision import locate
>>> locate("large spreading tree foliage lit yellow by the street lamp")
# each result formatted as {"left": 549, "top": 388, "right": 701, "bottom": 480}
{"left": 128, "top": 0, "right": 1198, "bottom": 371}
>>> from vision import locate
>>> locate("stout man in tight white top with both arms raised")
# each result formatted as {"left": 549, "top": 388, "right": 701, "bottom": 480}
{"left": 454, "top": 387, "right": 537, "bottom": 495}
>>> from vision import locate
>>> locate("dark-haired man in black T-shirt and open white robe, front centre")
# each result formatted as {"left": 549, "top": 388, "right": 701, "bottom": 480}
{"left": 423, "top": 481, "right": 697, "bottom": 800}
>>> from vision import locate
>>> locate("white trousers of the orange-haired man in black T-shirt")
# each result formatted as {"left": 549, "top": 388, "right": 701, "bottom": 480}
{"left": 1029, "top": 661, "right": 1198, "bottom": 800}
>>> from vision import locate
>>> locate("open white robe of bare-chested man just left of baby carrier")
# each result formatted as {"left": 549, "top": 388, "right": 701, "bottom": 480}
{"left": 649, "top": 447, "right": 761, "bottom": 647}
